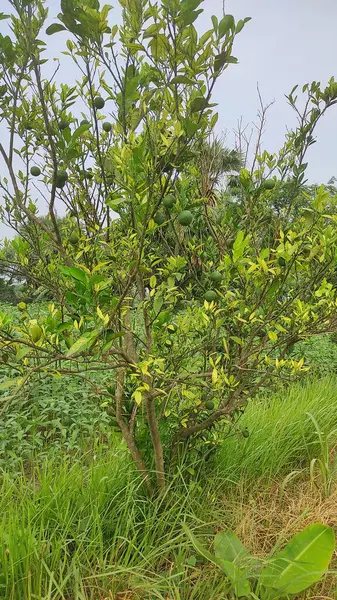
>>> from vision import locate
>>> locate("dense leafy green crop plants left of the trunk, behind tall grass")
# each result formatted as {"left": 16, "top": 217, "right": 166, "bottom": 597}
{"left": 0, "top": 373, "right": 114, "bottom": 472}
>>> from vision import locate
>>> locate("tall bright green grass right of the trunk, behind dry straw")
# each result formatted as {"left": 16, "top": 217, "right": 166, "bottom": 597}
{"left": 216, "top": 377, "right": 337, "bottom": 482}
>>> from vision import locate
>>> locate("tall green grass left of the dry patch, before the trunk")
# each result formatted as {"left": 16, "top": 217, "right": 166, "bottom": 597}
{"left": 0, "top": 454, "right": 228, "bottom": 600}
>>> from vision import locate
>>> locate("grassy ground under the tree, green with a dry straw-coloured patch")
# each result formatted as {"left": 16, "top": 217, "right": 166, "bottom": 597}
{"left": 0, "top": 378, "right": 337, "bottom": 600}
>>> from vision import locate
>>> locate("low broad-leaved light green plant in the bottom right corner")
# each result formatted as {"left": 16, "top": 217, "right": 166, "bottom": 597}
{"left": 185, "top": 523, "right": 335, "bottom": 600}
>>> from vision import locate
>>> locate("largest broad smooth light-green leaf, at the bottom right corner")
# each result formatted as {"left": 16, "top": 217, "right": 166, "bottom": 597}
{"left": 260, "top": 523, "right": 335, "bottom": 594}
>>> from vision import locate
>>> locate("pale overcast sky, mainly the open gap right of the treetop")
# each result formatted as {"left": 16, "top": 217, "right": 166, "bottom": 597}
{"left": 0, "top": 0, "right": 337, "bottom": 236}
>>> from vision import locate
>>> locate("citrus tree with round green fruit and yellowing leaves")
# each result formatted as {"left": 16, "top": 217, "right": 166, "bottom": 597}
{"left": 0, "top": 0, "right": 337, "bottom": 491}
